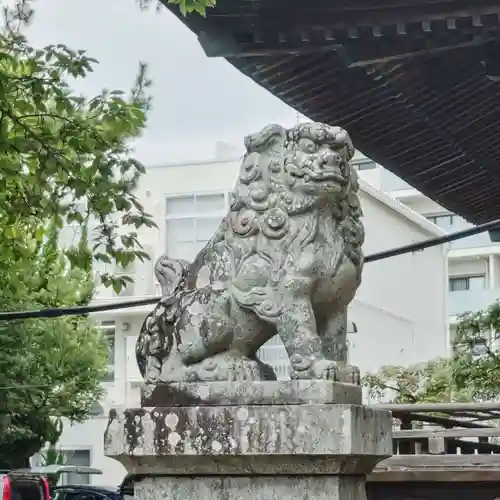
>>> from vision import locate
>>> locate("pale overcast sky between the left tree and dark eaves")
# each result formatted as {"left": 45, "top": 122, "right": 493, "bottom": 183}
{"left": 24, "top": 0, "right": 296, "bottom": 165}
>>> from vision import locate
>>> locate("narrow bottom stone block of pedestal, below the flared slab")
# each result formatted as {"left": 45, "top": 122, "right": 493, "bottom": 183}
{"left": 135, "top": 476, "right": 366, "bottom": 500}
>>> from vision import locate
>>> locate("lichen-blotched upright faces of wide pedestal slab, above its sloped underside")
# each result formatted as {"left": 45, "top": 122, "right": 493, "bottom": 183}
{"left": 106, "top": 405, "right": 391, "bottom": 467}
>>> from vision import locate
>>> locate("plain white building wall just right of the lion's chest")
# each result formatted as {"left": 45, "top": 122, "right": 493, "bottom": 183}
{"left": 350, "top": 188, "right": 448, "bottom": 371}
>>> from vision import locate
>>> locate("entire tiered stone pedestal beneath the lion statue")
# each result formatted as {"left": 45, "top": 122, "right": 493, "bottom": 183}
{"left": 105, "top": 381, "right": 392, "bottom": 500}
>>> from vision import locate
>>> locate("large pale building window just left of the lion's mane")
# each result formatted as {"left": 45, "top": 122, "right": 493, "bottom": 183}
{"left": 165, "top": 193, "right": 229, "bottom": 262}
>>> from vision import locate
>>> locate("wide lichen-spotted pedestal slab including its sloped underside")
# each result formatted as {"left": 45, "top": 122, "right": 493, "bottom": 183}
{"left": 105, "top": 404, "right": 392, "bottom": 475}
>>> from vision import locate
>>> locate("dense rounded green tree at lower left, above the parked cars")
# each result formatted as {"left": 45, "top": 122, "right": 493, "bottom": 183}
{"left": 0, "top": 225, "right": 107, "bottom": 468}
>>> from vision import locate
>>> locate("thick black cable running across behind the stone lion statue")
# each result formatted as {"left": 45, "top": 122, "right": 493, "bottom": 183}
{"left": 0, "top": 219, "right": 500, "bottom": 321}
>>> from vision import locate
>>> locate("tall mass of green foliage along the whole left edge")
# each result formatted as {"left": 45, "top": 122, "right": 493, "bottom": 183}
{"left": 0, "top": 1, "right": 154, "bottom": 468}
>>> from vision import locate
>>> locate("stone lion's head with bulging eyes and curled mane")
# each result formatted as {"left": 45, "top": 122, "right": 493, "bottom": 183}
{"left": 230, "top": 123, "right": 361, "bottom": 246}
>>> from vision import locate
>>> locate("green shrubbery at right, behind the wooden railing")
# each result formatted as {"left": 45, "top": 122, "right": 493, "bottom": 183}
{"left": 363, "top": 301, "right": 500, "bottom": 403}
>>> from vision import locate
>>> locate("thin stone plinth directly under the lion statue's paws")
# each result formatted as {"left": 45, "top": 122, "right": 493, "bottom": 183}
{"left": 141, "top": 380, "right": 362, "bottom": 407}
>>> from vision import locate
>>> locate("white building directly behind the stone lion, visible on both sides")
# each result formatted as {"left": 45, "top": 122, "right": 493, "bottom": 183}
{"left": 56, "top": 151, "right": 448, "bottom": 484}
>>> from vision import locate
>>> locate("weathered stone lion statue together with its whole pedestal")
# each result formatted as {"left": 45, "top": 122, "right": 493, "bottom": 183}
{"left": 105, "top": 123, "right": 386, "bottom": 500}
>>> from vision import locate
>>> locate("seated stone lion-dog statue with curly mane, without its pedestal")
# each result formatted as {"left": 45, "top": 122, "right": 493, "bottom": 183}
{"left": 136, "top": 123, "right": 364, "bottom": 384}
